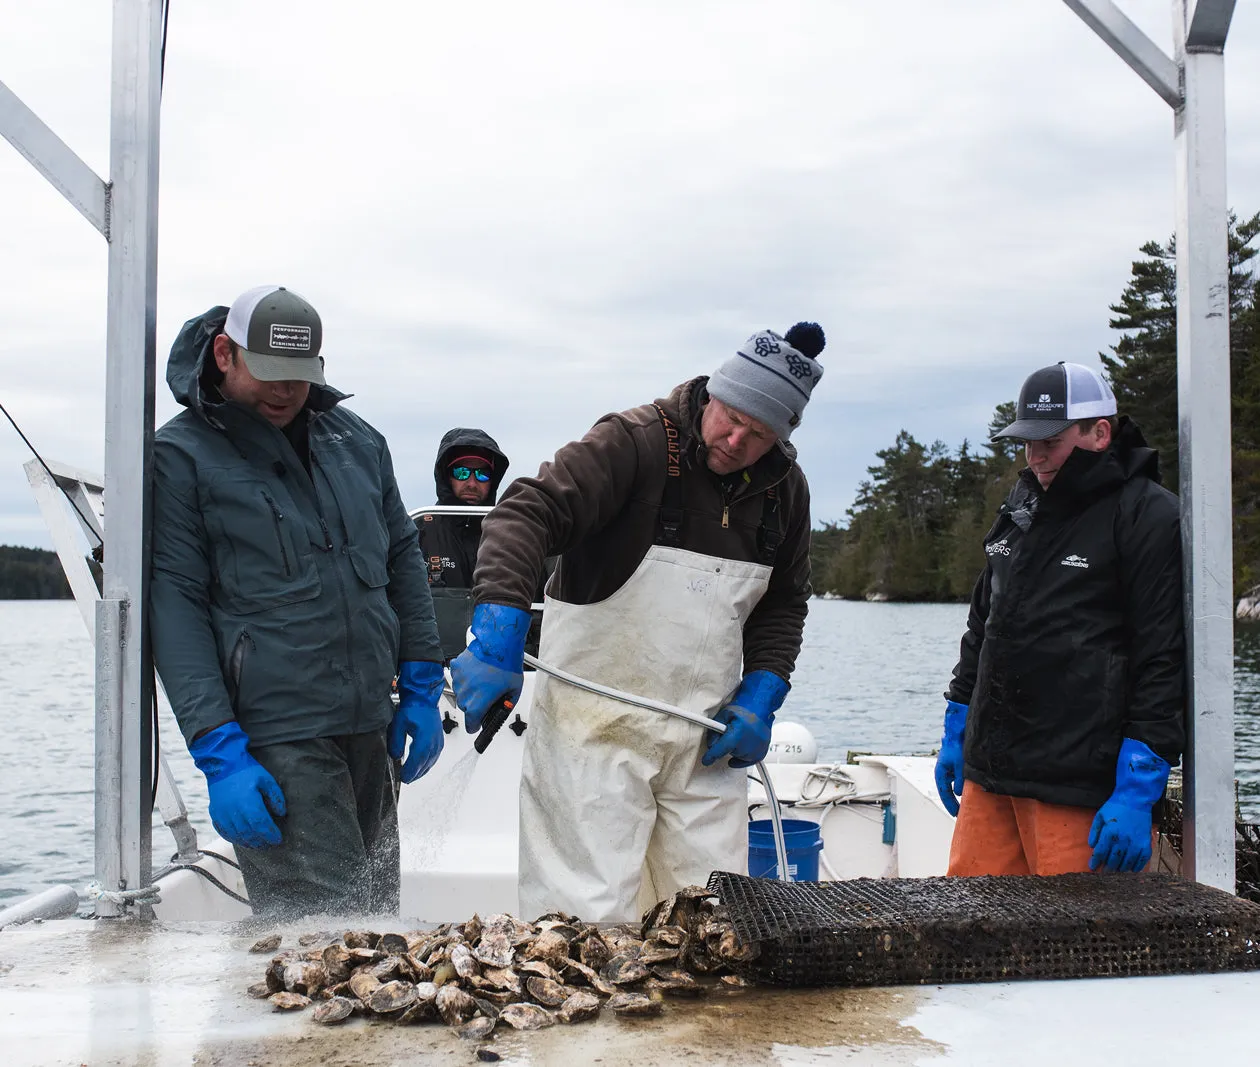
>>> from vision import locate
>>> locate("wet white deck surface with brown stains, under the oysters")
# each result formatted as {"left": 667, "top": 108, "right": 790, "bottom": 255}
{"left": 7, "top": 920, "right": 1260, "bottom": 1067}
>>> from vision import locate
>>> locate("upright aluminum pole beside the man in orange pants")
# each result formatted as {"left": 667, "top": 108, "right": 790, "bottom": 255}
{"left": 1173, "top": 0, "right": 1235, "bottom": 893}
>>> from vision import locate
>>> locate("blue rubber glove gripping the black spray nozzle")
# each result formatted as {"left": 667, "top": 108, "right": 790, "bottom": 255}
{"left": 451, "top": 603, "right": 529, "bottom": 733}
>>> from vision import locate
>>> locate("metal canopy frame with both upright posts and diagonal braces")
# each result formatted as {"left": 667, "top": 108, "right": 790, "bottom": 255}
{"left": 0, "top": 0, "right": 1235, "bottom": 915}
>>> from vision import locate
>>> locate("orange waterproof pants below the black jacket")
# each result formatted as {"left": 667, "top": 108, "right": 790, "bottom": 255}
{"left": 945, "top": 780, "right": 1096, "bottom": 874}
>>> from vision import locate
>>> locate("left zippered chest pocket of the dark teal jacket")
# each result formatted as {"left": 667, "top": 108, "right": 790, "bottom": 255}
{"left": 203, "top": 477, "right": 320, "bottom": 615}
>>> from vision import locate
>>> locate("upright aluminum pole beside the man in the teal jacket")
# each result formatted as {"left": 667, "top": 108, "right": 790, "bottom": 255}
{"left": 96, "top": 0, "right": 161, "bottom": 915}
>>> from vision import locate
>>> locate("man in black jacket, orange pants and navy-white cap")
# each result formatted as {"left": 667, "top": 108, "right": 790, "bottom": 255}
{"left": 936, "top": 363, "right": 1186, "bottom": 874}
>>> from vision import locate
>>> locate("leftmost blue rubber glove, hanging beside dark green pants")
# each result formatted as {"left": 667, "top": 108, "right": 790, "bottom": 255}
{"left": 188, "top": 719, "right": 285, "bottom": 848}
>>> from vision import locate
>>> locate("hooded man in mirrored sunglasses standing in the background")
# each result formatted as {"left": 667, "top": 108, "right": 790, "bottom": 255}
{"left": 418, "top": 426, "right": 508, "bottom": 661}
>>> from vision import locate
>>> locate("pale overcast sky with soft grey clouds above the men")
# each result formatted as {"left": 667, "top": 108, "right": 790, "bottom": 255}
{"left": 0, "top": 0, "right": 1260, "bottom": 545}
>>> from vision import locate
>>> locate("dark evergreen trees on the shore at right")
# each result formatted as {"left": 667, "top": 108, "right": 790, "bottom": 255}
{"left": 811, "top": 214, "right": 1260, "bottom": 601}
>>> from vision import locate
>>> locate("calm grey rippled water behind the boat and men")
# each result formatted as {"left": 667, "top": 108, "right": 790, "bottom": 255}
{"left": 0, "top": 600, "right": 1260, "bottom": 899}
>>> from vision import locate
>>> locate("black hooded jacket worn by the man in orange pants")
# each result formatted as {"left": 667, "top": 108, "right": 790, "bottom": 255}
{"left": 945, "top": 418, "right": 1186, "bottom": 807}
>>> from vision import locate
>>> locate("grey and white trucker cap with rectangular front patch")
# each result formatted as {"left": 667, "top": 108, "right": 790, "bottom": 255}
{"left": 223, "top": 285, "right": 326, "bottom": 385}
